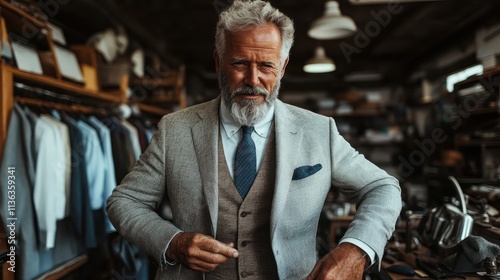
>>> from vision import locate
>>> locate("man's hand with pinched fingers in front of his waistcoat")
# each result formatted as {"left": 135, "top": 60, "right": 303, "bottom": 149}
{"left": 167, "top": 232, "right": 238, "bottom": 272}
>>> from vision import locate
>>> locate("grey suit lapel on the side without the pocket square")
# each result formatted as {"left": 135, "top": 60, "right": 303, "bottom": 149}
{"left": 191, "top": 97, "right": 220, "bottom": 237}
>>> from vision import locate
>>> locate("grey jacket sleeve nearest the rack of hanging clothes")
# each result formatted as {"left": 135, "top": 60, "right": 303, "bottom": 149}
{"left": 107, "top": 118, "right": 180, "bottom": 270}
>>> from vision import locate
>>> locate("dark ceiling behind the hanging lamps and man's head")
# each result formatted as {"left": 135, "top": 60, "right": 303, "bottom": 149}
{"left": 54, "top": 0, "right": 500, "bottom": 93}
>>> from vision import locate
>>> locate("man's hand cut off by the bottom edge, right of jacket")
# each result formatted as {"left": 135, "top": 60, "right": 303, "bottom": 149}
{"left": 307, "top": 243, "right": 368, "bottom": 280}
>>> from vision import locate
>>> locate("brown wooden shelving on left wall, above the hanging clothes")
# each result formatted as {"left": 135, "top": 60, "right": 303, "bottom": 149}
{"left": 0, "top": 0, "right": 187, "bottom": 280}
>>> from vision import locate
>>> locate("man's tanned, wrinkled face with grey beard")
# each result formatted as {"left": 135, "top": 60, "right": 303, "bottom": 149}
{"left": 215, "top": 24, "right": 288, "bottom": 125}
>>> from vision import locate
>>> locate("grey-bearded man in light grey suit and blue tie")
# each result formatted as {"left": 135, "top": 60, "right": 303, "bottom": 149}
{"left": 108, "top": 0, "right": 401, "bottom": 280}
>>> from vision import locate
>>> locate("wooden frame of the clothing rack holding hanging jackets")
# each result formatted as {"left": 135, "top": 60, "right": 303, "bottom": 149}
{"left": 0, "top": 59, "right": 127, "bottom": 280}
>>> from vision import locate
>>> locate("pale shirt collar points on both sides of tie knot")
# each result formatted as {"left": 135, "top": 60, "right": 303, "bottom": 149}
{"left": 219, "top": 98, "right": 274, "bottom": 138}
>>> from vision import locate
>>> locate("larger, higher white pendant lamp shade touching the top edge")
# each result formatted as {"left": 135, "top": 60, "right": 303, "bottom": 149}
{"left": 307, "top": 1, "right": 357, "bottom": 40}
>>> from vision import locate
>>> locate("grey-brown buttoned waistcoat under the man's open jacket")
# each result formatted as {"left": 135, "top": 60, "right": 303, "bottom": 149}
{"left": 206, "top": 129, "right": 278, "bottom": 280}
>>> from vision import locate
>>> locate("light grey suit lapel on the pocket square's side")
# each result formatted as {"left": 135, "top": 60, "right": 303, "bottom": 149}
{"left": 271, "top": 100, "right": 303, "bottom": 242}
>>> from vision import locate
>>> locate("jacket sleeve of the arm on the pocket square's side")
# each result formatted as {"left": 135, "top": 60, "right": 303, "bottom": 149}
{"left": 330, "top": 119, "right": 402, "bottom": 266}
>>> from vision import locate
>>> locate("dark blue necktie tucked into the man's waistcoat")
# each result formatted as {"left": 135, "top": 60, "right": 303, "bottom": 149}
{"left": 234, "top": 126, "right": 257, "bottom": 199}
